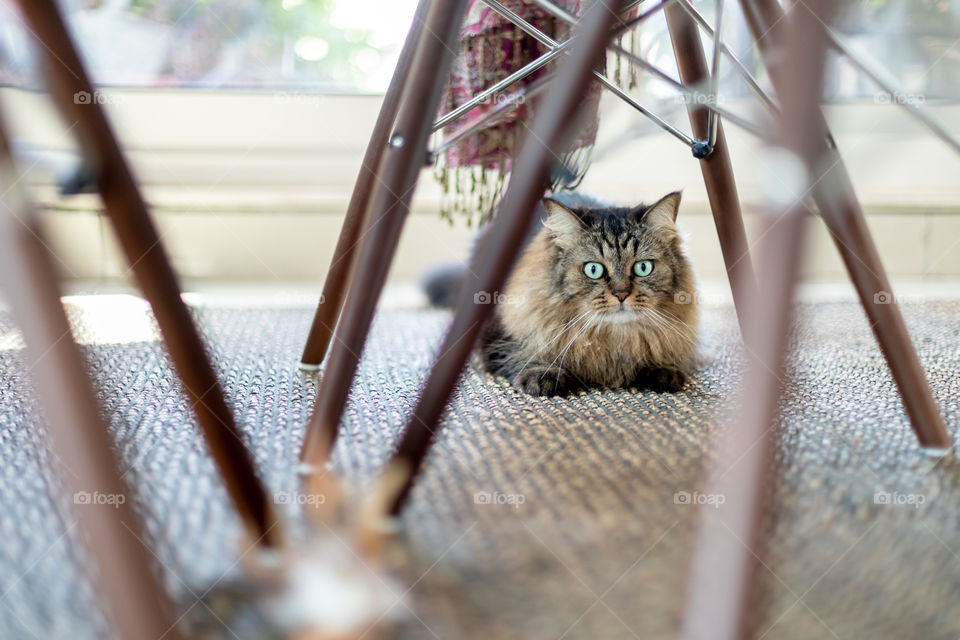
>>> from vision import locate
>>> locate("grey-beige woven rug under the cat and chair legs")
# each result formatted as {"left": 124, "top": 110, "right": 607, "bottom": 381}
{"left": 0, "top": 298, "right": 960, "bottom": 640}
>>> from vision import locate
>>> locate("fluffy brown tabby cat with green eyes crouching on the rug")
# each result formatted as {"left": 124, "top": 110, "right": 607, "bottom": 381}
{"left": 426, "top": 193, "right": 697, "bottom": 396}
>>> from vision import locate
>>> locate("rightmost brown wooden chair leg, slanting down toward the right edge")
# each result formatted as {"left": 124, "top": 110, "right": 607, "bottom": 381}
{"left": 745, "top": 0, "right": 953, "bottom": 456}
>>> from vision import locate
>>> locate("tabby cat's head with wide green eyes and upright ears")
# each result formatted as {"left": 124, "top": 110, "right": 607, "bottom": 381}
{"left": 544, "top": 193, "right": 690, "bottom": 324}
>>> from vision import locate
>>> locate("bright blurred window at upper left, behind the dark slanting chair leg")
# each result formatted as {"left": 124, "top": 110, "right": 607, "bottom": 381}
{"left": 0, "top": 0, "right": 415, "bottom": 93}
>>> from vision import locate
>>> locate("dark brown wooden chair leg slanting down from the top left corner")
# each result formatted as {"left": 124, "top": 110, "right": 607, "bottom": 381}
{"left": 20, "top": 0, "right": 280, "bottom": 545}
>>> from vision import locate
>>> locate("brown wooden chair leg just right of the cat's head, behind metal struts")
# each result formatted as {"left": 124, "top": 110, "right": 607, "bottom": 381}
{"left": 664, "top": 3, "right": 757, "bottom": 332}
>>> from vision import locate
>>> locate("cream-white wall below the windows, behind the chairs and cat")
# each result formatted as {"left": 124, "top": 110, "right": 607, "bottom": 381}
{"left": 0, "top": 89, "right": 960, "bottom": 281}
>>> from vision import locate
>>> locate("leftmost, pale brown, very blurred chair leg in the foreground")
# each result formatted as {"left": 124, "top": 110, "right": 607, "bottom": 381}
{"left": 0, "top": 124, "right": 182, "bottom": 640}
